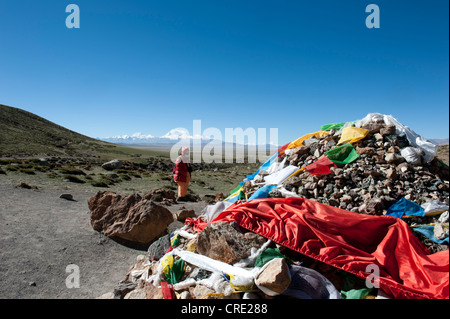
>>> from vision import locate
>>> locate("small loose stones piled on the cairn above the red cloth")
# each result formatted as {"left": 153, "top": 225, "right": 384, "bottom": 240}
{"left": 284, "top": 122, "right": 449, "bottom": 215}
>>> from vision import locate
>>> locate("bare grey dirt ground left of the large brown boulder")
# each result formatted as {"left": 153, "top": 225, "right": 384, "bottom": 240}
{"left": 0, "top": 175, "right": 207, "bottom": 299}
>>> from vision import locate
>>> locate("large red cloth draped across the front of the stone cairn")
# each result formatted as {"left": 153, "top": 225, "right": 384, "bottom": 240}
{"left": 188, "top": 197, "right": 449, "bottom": 299}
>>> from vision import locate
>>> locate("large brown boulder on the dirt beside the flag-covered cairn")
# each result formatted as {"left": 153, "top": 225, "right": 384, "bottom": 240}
{"left": 88, "top": 191, "right": 173, "bottom": 245}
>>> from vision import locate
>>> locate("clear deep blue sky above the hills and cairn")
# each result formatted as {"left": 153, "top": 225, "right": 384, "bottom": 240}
{"left": 0, "top": 0, "right": 449, "bottom": 144}
